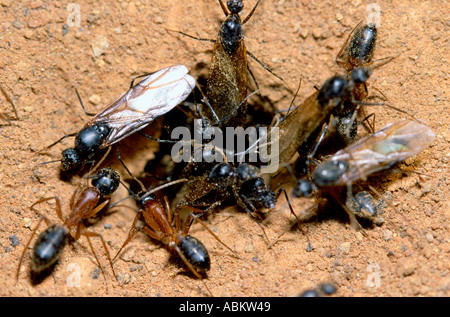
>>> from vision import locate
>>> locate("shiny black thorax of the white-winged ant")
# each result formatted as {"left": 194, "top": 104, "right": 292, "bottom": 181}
{"left": 75, "top": 123, "right": 110, "bottom": 157}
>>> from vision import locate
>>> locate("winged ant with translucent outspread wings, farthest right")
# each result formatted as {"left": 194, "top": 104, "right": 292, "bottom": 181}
{"left": 293, "top": 120, "right": 435, "bottom": 225}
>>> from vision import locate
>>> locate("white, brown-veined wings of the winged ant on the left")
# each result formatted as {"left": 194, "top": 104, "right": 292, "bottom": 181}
{"left": 87, "top": 65, "right": 195, "bottom": 146}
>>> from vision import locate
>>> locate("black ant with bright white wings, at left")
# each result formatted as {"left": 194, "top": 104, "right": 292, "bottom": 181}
{"left": 41, "top": 65, "right": 195, "bottom": 172}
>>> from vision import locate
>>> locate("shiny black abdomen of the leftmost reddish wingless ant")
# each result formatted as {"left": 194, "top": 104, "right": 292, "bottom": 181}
{"left": 32, "top": 225, "right": 69, "bottom": 273}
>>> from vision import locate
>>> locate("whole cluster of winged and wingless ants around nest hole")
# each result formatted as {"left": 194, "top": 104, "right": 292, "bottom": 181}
{"left": 13, "top": 0, "right": 434, "bottom": 294}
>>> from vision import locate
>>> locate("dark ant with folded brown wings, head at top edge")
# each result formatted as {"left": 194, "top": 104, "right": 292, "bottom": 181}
{"left": 174, "top": 0, "right": 284, "bottom": 126}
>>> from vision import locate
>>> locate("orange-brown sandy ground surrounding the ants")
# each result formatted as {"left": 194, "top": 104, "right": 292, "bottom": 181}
{"left": 0, "top": 0, "right": 450, "bottom": 297}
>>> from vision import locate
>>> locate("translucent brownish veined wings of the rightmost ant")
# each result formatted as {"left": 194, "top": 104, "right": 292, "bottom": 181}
{"left": 330, "top": 120, "right": 436, "bottom": 185}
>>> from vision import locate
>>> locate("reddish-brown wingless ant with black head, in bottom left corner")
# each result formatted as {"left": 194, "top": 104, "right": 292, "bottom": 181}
{"left": 16, "top": 168, "right": 120, "bottom": 280}
